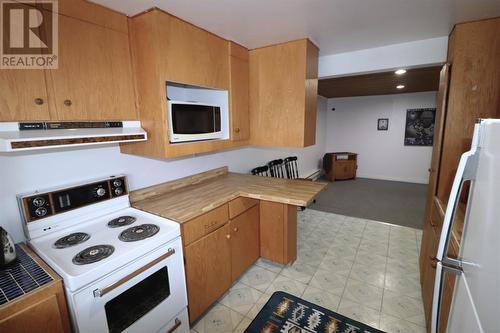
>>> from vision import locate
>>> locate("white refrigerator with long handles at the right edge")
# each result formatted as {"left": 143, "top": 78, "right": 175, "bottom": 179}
{"left": 431, "top": 119, "right": 500, "bottom": 333}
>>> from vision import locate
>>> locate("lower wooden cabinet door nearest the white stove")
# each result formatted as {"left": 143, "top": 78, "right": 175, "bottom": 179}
{"left": 184, "top": 224, "right": 231, "bottom": 322}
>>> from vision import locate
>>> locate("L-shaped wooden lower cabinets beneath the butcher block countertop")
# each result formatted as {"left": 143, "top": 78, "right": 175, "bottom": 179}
{"left": 185, "top": 197, "right": 297, "bottom": 323}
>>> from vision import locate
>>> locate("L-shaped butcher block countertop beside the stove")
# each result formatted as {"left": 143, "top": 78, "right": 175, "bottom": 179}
{"left": 130, "top": 167, "right": 328, "bottom": 223}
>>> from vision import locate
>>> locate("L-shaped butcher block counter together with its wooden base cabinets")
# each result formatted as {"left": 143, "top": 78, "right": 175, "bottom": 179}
{"left": 130, "top": 167, "right": 327, "bottom": 323}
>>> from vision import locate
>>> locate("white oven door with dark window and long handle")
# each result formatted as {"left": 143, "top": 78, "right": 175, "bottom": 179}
{"left": 72, "top": 238, "right": 189, "bottom": 333}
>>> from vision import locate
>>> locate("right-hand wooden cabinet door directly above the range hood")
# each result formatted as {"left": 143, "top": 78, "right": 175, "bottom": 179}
{"left": 46, "top": 15, "right": 137, "bottom": 120}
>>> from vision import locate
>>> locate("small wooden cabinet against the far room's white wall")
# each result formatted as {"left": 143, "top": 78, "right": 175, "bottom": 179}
{"left": 323, "top": 152, "right": 358, "bottom": 182}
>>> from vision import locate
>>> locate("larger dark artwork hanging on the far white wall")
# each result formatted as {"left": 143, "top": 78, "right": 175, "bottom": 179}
{"left": 404, "top": 108, "right": 436, "bottom": 146}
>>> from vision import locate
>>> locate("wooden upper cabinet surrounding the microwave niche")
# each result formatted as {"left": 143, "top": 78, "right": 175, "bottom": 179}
{"left": 121, "top": 9, "right": 248, "bottom": 158}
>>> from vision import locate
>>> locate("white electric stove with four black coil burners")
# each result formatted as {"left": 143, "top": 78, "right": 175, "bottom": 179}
{"left": 18, "top": 176, "right": 189, "bottom": 333}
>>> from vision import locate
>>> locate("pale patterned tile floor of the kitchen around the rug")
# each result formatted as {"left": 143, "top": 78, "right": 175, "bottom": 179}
{"left": 192, "top": 209, "right": 425, "bottom": 333}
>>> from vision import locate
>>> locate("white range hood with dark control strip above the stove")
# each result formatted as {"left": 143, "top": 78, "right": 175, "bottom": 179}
{"left": 0, "top": 121, "right": 148, "bottom": 152}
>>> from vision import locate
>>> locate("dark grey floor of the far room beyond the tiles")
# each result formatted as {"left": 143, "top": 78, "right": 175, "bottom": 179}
{"left": 309, "top": 178, "right": 427, "bottom": 229}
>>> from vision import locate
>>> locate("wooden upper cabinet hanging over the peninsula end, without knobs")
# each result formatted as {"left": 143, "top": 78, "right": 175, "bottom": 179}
{"left": 249, "top": 39, "right": 318, "bottom": 147}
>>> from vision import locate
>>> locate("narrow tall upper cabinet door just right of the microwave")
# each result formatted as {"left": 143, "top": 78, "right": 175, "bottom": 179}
{"left": 229, "top": 42, "right": 250, "bottom": 141}
